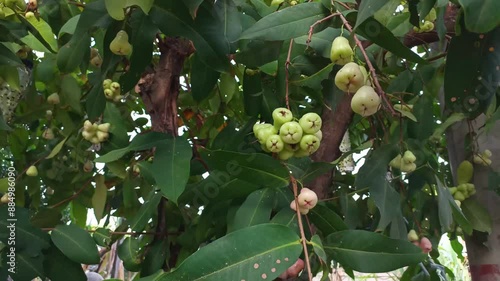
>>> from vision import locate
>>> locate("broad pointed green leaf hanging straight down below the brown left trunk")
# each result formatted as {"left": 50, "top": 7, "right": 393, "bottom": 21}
{"left": 151, "top": 137, "right": 193, "bottom": 204}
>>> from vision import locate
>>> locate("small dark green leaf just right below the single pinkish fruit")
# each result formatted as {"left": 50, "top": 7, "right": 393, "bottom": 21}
{"left": 309, "top": 202, "right": 347, "bottom": 237}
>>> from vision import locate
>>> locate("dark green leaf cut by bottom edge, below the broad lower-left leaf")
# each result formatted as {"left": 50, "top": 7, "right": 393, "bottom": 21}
{"left": 43, "top": 246, "right": 87, "bottom": 281}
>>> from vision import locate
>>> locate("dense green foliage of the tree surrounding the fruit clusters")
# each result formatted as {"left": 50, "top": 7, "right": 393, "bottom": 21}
{"left": 0, "top": 0, "right": 500, "bottom": 280}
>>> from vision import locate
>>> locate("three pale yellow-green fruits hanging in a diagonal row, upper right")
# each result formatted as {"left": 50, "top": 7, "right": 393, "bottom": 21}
{"left": 330, "top": 36, "right": 381, "bottom": 117}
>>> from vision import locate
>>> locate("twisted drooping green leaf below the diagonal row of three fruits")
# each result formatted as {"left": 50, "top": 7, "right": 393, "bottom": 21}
{"left": 354, "top": 144, "right": 402, "bottom": 230}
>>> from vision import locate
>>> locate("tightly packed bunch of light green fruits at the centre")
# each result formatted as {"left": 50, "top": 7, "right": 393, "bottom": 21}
{"left": 253, "top": 107, "right": 323, "bottom": 160}
